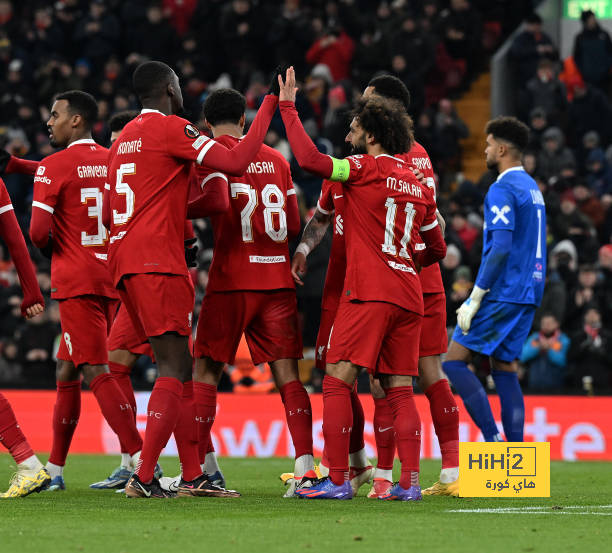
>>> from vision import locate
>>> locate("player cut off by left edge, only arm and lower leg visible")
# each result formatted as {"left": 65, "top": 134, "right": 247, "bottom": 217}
{"left": 0, "top": 179, "right": 51, "bottom": 499}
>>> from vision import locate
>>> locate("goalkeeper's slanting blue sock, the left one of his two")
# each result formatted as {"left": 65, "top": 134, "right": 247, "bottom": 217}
{"left": 442, "top": 361, "right": 498, "bottom": 442}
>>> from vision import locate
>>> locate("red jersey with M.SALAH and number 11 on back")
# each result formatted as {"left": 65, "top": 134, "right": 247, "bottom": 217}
{"left": 342, "top": 154, "right": 438, "bottom": 315}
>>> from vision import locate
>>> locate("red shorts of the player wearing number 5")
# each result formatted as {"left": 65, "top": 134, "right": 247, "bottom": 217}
{"left": 119, "top": 273, "right": 195, "bottom": 343}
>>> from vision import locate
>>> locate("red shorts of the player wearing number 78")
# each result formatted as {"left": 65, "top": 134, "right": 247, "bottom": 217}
{"left": 194, "top": 290, "right": 302, "bottom": 365}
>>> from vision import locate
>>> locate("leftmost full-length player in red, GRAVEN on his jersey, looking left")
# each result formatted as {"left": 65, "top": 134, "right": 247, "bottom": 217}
{"left": 30, "top": 90, "right": 142, "bottom": 490}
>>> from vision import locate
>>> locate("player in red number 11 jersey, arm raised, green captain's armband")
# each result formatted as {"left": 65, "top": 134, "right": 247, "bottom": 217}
{"left": 280, "top": 68, "right": 446, "bottom": 500}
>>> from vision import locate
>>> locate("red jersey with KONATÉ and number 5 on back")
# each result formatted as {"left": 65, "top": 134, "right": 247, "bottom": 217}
{"left": 108, "top": 109, "right": 214, "bottom": 284}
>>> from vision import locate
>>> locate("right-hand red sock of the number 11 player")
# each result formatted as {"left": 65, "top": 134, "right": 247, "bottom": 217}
{"left": 385, "top": 386, "right": 421, "bottom": 490}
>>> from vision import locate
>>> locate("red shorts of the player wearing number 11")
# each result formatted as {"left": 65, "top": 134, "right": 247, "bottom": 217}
{"left": 327, "top": 299, "right": 423, "bottom": 376}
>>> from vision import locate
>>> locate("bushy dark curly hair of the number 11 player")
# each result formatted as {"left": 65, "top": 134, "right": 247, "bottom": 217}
{"left": 352, "top": 96, "right": 414, "bottom": 154}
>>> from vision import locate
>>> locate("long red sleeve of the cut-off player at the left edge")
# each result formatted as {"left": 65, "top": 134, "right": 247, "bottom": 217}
{"left": 0, "top": 179, "right": 45, "bottom": 317}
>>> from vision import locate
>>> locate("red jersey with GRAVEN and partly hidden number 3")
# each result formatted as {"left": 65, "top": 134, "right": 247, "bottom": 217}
{"left": 32, "top": 139, "right": 117, "bottom": 299}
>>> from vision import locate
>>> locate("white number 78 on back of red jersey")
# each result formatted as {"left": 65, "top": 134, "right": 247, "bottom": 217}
{"left": 230, "top": 182, "right": 287, "bottom": 242}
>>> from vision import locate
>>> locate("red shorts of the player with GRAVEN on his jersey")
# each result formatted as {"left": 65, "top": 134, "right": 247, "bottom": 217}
{"left": 57, "top": 295, "right": 119, "bottom": 367}
